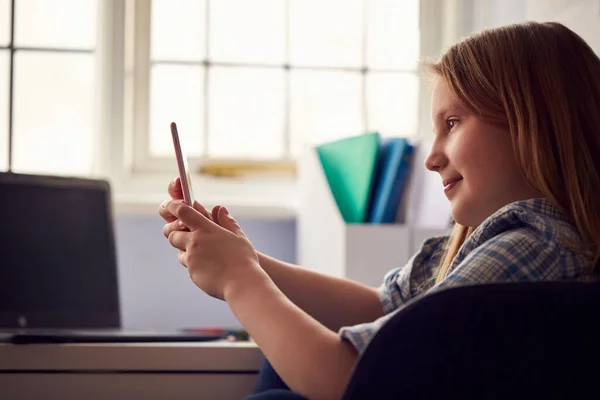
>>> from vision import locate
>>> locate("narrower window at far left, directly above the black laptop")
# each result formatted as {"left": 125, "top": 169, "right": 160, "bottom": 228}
{"left": 0, "top": 0, "right": 98, "bottom": 176}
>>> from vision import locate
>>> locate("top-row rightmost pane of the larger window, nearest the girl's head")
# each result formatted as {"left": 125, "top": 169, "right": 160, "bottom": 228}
{"left": 367, "top": 0, "right": 419, "bottom": 69}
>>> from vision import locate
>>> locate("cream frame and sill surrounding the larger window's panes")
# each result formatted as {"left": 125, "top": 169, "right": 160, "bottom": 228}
{"left": 97, "top": 0, "right": 450, "bottom": 219}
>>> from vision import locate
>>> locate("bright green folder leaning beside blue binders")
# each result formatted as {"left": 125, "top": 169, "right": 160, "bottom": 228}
{"left": 317, "top": 132, "right": 379, "bottom": 224}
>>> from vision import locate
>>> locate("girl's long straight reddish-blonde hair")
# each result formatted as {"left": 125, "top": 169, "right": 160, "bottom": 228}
{"left": 429, "top": 22, "right": 600, "bottom": 283}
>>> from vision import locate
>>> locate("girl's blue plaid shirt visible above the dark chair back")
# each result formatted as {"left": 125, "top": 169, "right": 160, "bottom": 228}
{"left": 340, "top": 228, "right": 561, "bottom": 353}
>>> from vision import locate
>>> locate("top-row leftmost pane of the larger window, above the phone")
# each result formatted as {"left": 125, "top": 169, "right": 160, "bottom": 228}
{"left": 150, "top": 0, "right": 206, "bottom": 61}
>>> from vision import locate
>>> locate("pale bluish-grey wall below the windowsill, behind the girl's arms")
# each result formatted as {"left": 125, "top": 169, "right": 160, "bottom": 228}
{"left": 115, "top": 214, "right": 296, "bottom": 330}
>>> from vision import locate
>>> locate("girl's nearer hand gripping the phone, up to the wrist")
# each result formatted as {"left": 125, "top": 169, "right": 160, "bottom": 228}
{"left": 160, "top": 200, "right": 265, "bottom": 300}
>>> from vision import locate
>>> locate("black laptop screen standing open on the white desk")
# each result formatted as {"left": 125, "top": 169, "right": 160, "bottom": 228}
{"left": 0, "top": 173, "right": 120, "bottom": 328}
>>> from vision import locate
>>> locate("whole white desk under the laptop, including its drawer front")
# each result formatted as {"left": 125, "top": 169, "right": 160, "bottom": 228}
{"left": 0, "top": 341, "right": 262, "bottom": 400}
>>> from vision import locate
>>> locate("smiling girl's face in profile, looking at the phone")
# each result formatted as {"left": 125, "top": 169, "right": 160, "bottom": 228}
{"left": 425, "top": 78, "right": 541, "bottom": 227}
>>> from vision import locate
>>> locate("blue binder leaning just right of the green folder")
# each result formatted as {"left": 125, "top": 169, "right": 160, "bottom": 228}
{"left": 367, "top": 138, "right": 414, "bottom": 224}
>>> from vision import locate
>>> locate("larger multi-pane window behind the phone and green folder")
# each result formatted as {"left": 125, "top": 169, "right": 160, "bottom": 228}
{"left": 128, "top": 0, "right": 420, "bottom": 178}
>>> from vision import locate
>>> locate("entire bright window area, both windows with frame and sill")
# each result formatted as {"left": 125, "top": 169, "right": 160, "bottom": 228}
{"left": 0, "top": 0, "right": 441, "bottom": 215}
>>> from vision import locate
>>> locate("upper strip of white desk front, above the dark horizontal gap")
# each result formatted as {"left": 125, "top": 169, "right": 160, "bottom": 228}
{"left": 0, "top": 341, "right": 262, "bottom": 373}
